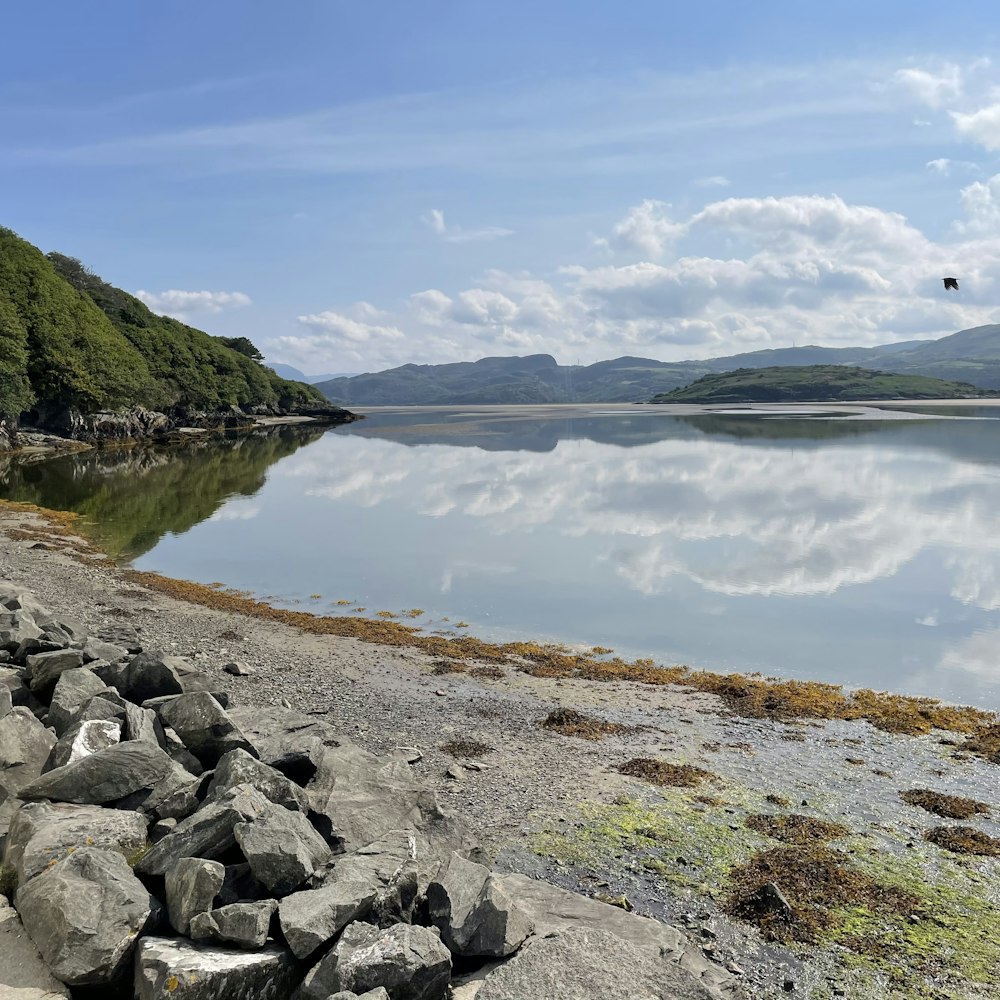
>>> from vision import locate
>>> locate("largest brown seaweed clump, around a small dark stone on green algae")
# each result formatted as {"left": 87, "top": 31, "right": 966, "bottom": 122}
{"left": 725, "top": 844, "right": 922, "bottom": 944}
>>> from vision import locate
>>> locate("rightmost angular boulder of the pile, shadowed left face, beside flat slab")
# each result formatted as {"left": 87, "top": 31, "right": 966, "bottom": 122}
{"left": 427, "top": 854, "right": 534, "bottom": 958}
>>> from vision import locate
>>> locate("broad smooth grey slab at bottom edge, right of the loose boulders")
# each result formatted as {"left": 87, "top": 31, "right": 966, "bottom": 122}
{"left": 476, "top": 927, "right": 713, "bottom": 1000}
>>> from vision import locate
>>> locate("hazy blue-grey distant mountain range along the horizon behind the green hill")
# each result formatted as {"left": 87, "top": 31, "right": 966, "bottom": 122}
{"left": 316, "top": 324, "right": 1000, "bottom": 406}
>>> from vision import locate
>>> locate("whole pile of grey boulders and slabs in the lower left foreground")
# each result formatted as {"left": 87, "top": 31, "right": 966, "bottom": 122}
{"left": 0, "top": 583, "right": 735, "bottom": 1000}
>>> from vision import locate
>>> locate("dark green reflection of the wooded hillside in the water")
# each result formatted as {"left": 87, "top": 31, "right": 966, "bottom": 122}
{"left": 0, "top": 427, "right": 324, "bottom": 559}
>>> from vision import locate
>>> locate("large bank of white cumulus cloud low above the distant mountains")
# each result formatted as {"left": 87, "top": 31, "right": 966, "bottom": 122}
{"left": 267, "top": 188, "right": 1000, "bottom": 371}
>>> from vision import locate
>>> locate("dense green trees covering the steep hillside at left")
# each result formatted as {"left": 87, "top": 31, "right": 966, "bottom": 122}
{"left": 0, "top": 228, "right": 325, "bottom": 418}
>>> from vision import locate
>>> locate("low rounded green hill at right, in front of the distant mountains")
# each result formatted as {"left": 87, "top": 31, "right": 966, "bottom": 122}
{"left": 650, "top": 365, "right": 997, "bottom": 403}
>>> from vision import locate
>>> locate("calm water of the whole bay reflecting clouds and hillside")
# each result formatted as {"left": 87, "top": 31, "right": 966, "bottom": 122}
{"left": 0, "top": 409, "right": 1000, "bottom": 708}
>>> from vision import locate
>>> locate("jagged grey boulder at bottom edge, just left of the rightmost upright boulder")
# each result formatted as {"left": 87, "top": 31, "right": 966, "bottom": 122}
{"left": 299, "top": 923, "right": 454, "bottom": 1000}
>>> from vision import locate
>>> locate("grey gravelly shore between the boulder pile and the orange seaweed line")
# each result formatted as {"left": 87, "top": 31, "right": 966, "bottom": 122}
{"left": 0, "top": 507, "right": 1000, "bottom": 1000}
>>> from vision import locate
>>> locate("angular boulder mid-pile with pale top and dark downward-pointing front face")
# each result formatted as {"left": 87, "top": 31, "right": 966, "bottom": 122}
{"left": 233, "top": 802, "right": 330, "bottom": 896}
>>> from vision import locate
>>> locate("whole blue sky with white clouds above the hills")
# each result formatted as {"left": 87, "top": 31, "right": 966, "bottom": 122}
{"left": 0, "top": 0, "right": 1000, "bottom": 371}
